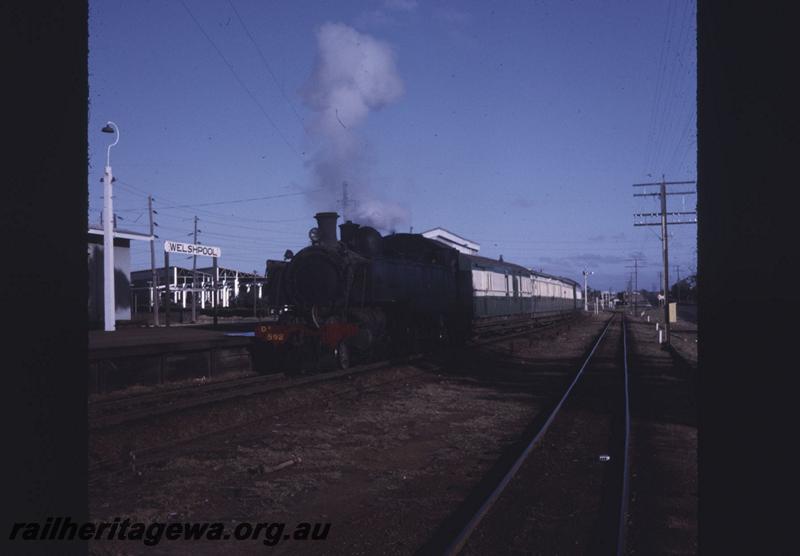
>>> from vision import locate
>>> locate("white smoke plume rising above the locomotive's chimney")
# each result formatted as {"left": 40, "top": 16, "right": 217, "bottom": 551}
{"left": 302, "top": 23, "right": 409, "bottom": 230}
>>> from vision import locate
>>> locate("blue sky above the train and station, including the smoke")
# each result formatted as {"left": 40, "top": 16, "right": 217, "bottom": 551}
{"left": 87, "top": 0, "right": 696, "bottom": 290}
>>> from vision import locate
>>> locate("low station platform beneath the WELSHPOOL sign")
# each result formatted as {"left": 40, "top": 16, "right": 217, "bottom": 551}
{"left": 88, "top": 323, "right": 255, "bottom": 394}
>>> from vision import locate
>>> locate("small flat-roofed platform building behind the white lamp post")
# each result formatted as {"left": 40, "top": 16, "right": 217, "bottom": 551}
{"left": 87, "top": 228, "right": 152, "bottom": 325}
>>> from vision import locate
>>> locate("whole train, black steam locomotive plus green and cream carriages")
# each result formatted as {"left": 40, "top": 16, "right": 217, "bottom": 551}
{"left": 253, "top": 212, "right": 582, "bottom": 372}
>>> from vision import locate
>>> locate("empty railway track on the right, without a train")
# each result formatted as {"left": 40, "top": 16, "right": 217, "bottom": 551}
{"left": 417, "top": 314, "right": 630, "bottom": 555}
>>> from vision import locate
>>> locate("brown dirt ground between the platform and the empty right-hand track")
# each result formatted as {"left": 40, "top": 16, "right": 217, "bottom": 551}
{"left": 89, "top": 315, "right": 692, "bottom": 554}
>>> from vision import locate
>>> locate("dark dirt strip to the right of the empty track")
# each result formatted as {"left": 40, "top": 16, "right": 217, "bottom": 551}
{"left": 627, "top": 314, "right": 699, "bottom": 554}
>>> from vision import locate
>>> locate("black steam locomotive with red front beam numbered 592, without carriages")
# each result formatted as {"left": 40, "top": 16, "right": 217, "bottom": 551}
{"left": 254, "top": 212, "right": 466, "bottom": 370}
